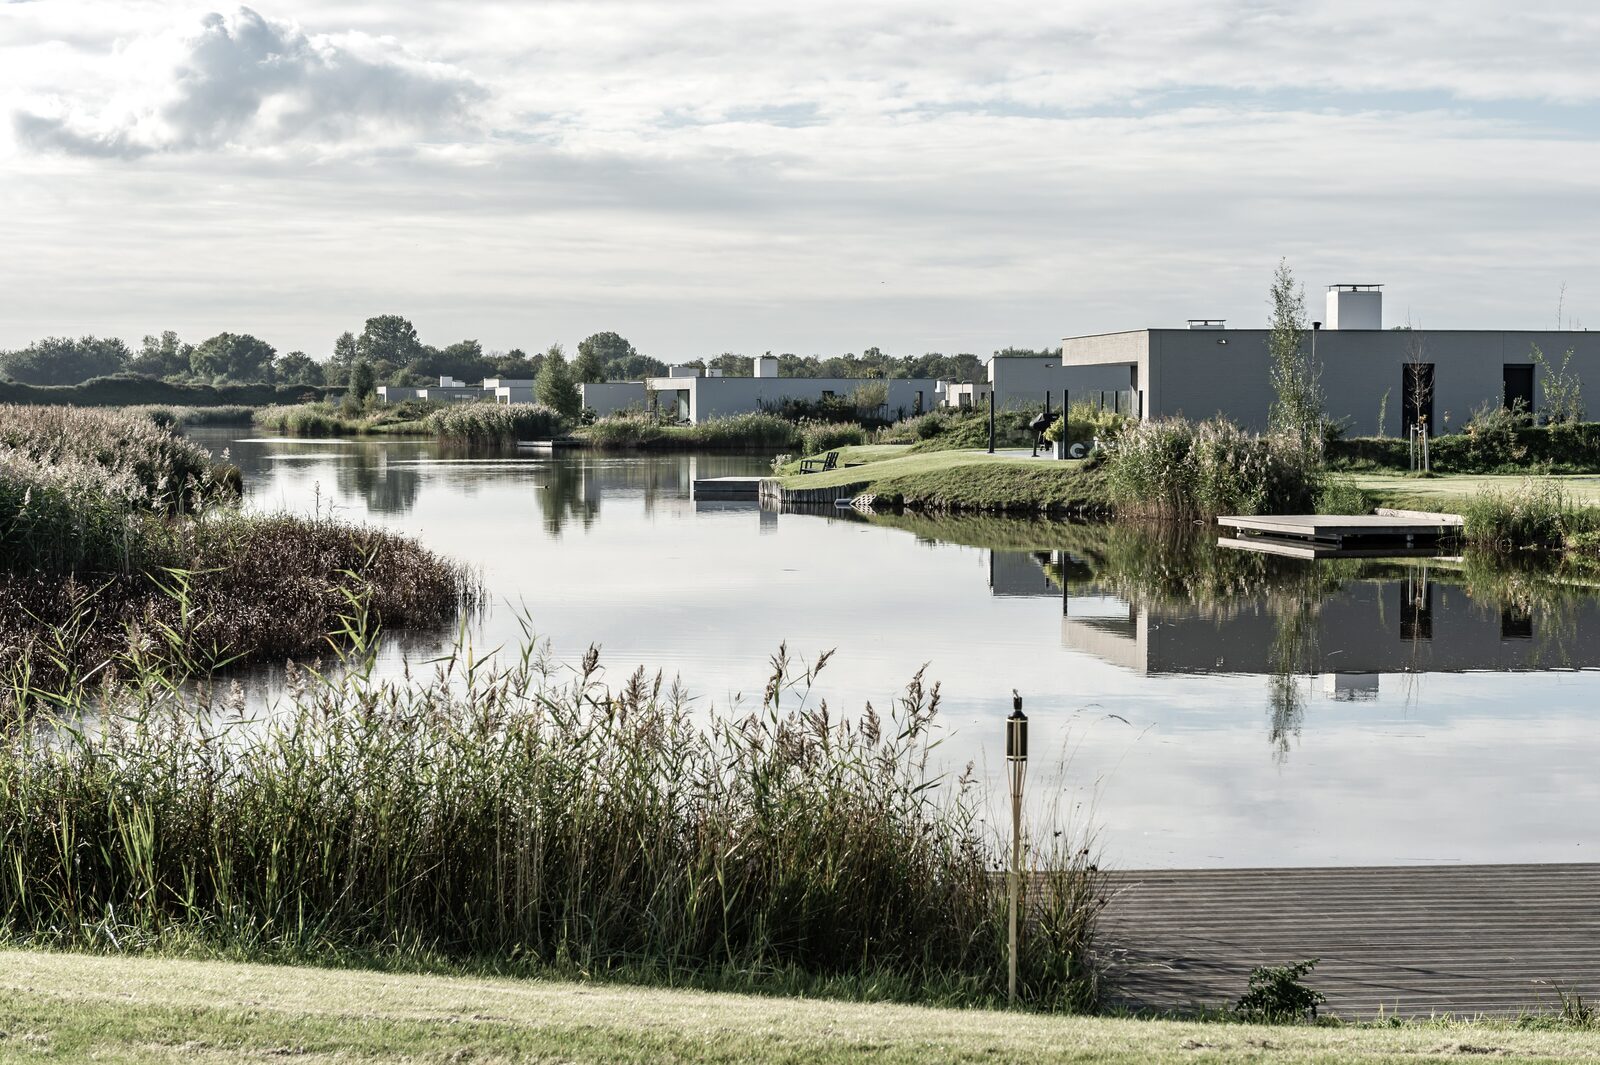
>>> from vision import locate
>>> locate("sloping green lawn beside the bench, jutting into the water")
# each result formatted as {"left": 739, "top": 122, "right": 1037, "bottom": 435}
{"left": 779, "top": 445, "right": 1106, "bottom": 512}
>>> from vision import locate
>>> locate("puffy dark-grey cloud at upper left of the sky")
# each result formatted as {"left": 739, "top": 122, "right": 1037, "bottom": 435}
{"left": 13, "top": 8, "right": 485, "bottom": 158}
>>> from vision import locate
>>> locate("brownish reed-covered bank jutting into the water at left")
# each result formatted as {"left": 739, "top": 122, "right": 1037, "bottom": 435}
{"left": 0, "top": 406, "right": 477, "bottom": 684}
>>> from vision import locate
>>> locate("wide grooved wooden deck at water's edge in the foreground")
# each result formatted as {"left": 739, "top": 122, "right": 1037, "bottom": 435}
{"left": 1099, "top": 864, "right": 1600, "bottom": 1019}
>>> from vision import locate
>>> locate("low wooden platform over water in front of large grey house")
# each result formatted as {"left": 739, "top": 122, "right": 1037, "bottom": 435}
{"left": 1216, "top": 509, "right": 1462, "bottom": 558}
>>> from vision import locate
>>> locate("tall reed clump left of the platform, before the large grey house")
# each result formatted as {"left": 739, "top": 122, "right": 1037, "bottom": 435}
{"left": 1104, "top": 417, "right": 1322, "bottom": 520}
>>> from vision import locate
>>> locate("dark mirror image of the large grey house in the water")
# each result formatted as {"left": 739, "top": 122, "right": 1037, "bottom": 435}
{"left": 990, "top": 552, "right": 1600, "bottom": 674}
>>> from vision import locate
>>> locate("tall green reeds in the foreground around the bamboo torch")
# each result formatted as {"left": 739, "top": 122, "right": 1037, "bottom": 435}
{"left": 0, "top": 630, "right": 1102, "bottom": 1009}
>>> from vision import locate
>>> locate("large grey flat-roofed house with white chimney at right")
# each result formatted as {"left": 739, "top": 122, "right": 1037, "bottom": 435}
{"left": 1061, "top": 285, "right": 1600, "bottom": 437}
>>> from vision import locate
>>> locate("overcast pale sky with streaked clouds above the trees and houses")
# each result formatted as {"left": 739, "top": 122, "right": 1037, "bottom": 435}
{"left": 0, "top": 0, "right": 1600, "bottom": 360}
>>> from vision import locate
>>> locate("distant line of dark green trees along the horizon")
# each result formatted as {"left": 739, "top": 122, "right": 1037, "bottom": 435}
{"left": 0, "top": 315, "right": 1058, "bottom": 395}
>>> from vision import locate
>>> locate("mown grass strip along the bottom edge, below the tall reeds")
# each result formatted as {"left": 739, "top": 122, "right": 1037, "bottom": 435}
{"left": 0, "top": 953, "right": 1600, "bottom": 1065}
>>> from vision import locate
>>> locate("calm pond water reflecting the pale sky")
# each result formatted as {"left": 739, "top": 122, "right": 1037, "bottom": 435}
{"left": 192, "top": 430, "right": 1600, "bottom": 868}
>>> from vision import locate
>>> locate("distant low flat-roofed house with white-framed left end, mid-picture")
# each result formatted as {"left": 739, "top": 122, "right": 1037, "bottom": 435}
{"left": 581, "top": 355, "right": 944, "bottom": 422}
